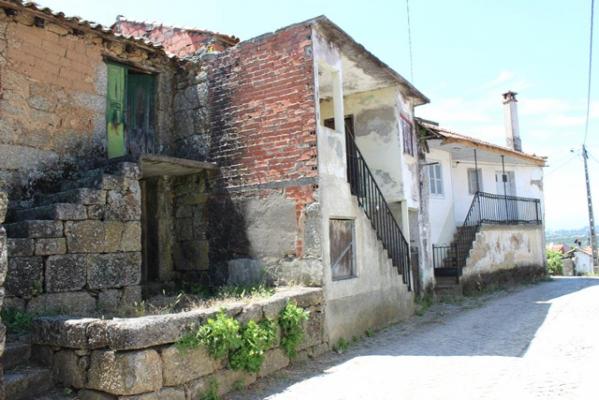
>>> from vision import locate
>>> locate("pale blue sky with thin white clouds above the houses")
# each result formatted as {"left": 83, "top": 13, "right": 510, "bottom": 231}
{"left": 39, "top": 0, "right": 599, "bottom": 229}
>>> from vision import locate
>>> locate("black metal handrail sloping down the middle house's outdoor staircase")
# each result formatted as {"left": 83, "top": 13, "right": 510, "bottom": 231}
{"left": 345, "top": 132, "right": 412, "bottom": 290}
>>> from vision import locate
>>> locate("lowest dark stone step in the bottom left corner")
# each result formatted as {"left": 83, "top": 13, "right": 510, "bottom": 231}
{"left": 4, "top": 366, "right": 53, "bottom": 400}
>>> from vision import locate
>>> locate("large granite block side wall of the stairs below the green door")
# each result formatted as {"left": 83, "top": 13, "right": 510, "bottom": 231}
{"left": 5, "top": 163, "right": 141, "bottom": 315}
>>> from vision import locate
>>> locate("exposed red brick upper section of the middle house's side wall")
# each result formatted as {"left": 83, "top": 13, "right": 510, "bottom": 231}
{"left": 207, "top": 25, "right": 318, "bottom": 256}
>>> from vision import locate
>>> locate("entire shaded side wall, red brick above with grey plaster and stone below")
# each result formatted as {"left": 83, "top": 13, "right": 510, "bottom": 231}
{"left": 174, "top": 25, "right": 322, "bottom": 282}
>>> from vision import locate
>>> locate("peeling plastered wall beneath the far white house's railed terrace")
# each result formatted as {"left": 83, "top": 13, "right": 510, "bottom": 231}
{"left": 460, "top": 225, "right": 546, "bottom": 293}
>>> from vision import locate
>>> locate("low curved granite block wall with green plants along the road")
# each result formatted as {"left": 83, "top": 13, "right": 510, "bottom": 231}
{"left": 32, "top": 288, "right": 328, "bottom": 400}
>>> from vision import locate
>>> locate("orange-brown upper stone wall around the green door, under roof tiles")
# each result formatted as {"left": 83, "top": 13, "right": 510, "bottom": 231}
{"left": 0, "top": 9, "right": 174, "bottom": 199}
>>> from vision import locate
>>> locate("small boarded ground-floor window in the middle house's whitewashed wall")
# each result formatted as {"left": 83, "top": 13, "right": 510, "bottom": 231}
{"left": 329, "top": 219, "right": 355, "bottom": 280}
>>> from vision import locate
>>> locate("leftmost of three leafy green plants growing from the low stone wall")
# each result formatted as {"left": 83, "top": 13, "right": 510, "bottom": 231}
{"left": 197, "top": 311, "right": 241, "bottom": 359}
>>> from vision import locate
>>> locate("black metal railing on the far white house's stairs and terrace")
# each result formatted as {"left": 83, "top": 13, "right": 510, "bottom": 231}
{"left": 433, "top": 192, "right": 543, "bottom": 275}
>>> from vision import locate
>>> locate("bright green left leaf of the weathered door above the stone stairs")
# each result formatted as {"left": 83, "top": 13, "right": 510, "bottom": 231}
{"left": 106, "top": 64, "right": 127, "bottom": 158}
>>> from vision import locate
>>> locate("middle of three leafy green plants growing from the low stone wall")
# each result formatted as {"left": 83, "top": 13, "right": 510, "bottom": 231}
{"left": 229, "top": 320, "right": 276, "bottom": 372}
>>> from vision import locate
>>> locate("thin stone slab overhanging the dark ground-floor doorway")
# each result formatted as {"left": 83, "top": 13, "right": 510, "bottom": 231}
{"left": 139, "top": 154, "right": 218, "bottom": 178}
